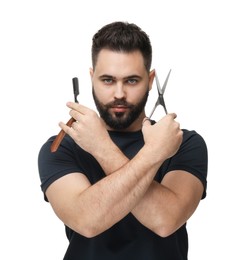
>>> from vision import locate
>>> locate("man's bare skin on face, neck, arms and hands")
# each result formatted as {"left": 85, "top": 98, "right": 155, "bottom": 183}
{"left": 46, "top": 50, "right": 203, "bottom": 237}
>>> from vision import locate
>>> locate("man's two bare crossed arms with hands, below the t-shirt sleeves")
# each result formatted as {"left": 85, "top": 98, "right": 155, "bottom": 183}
{"left": 46, "top": 101, "right": 203, "bottom": 237}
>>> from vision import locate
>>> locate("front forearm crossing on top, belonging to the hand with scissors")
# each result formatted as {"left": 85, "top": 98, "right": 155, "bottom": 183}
{"left": 77, "top": 147, "right": 159, "bottom": 236}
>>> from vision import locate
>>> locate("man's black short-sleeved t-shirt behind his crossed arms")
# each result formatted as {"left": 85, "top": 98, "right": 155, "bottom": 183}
{"left": 38, "top": 130, "right": 208, "bottom": 260}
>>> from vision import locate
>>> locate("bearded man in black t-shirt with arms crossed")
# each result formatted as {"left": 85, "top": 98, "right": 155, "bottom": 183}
{"left": 38, "top": 22, "right": 207, "bottom": 260}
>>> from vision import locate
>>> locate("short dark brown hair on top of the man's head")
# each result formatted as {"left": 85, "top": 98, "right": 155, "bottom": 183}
{"left": 92, "top": 22, "right": 152, "bottom": 71}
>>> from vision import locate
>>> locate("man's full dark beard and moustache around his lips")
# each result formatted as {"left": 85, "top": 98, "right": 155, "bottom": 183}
{"left": 92, "top": 88, "right": 149, "bottom": 130}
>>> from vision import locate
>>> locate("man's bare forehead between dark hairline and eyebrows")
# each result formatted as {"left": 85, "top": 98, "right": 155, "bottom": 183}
{"left": 95, "top": 49, "right": 146, "bottom": 77}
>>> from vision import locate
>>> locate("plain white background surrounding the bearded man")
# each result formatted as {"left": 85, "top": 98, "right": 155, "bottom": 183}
{"left": 0, "top": 0, "right": 241, "bottom": 260}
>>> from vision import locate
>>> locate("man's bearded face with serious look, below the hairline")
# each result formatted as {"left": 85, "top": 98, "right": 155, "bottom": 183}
{"left": 90, "top": 49, "right": 152, "bottom": 131}
